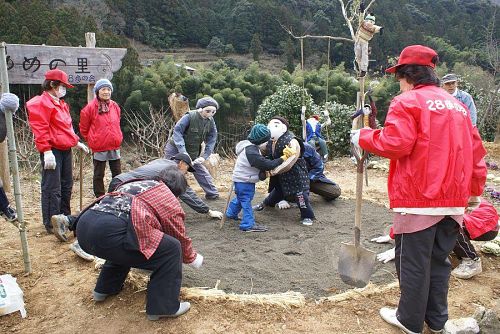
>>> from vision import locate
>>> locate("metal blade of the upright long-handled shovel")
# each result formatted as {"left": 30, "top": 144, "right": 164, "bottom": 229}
{"left": 338, "top": 243, "right": 375, "bottom": 288}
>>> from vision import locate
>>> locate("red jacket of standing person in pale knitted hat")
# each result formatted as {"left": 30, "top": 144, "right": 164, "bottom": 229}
{"left": 80, "top": 98, "right": 123, "bottom": 152}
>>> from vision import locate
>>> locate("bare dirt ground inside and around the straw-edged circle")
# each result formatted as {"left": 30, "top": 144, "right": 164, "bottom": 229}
{"left": 0, "top": 158, "right": 500, "bottom": 333}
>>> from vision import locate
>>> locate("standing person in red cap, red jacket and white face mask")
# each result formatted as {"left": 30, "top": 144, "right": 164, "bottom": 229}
{"left": 26, "top": 69, "right": 89, "bottom": 233}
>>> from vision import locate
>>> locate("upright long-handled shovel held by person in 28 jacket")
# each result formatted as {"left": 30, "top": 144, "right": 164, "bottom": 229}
{"left": 338, "top": 88, "right": 375, "bottom": 288}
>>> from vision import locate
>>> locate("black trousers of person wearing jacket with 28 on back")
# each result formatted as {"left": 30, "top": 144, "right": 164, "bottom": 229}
{"left": 395, "top": 217, "right": 459, "bottom": 333}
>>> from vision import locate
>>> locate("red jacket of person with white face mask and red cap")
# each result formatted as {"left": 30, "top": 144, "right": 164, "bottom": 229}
{"left": 26, "top": 92, "right": 79, "bottom": 152}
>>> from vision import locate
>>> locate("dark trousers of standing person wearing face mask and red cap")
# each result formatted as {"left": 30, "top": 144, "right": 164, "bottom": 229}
{"left": 40, "top": 148, "right": 73, "bottom": 229}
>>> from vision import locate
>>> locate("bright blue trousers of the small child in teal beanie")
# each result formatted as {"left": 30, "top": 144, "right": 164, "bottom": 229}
{"left": 226, "top": 182, "right": 255, "bottom": 230}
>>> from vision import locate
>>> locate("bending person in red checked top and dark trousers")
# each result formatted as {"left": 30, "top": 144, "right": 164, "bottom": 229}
{"left": 77, "top": 170, "right": 203, "bottom": 320}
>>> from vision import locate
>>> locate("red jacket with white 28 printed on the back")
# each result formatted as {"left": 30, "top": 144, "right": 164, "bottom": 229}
{"left": 359, "top": 85, "right": 486, "bottom": 208}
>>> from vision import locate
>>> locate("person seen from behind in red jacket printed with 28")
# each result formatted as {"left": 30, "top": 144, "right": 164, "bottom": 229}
{"left": 351, "top": 45, "right": 486, "bottom": 333}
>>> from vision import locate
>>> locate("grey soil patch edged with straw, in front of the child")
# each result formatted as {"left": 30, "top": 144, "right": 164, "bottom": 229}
{"left": 183, "top": 194, "right": 394, "bottom": 298}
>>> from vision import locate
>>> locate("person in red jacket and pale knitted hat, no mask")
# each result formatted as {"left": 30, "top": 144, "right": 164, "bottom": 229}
{"left": 80, "top": 79, "right": 123, "bottom": 197}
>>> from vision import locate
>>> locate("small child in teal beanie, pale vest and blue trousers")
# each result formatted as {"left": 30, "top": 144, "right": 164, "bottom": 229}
{"left": 226, "top": 124, "right": 287, "bottom": 232}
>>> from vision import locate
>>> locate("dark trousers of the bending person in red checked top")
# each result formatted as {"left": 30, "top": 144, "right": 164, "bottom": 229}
{"left": 77, "top": 210, "right": 182, "bottom": 315}
